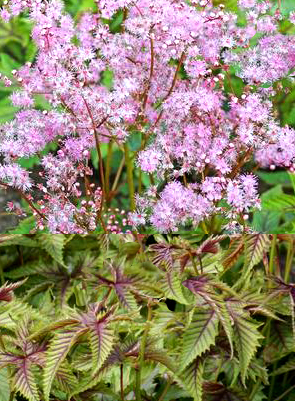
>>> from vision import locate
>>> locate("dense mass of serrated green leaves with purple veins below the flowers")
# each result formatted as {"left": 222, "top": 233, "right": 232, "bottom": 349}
{"left": 0, "top": 234, "right": 295, "bottom": 401}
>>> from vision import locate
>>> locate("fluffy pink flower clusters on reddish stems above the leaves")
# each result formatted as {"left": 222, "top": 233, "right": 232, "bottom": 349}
{"left": 0, "top": 0, "right": 295, "bottom": 234}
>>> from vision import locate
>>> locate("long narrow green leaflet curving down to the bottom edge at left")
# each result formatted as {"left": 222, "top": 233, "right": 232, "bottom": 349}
{"left": 43, "top": 327, "right": 86, "bottom": 401}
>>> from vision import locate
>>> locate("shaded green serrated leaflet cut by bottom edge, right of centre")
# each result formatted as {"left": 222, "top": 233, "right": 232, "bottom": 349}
{"left": 180, "top": 357, "right": 204, "bottom": 401}
